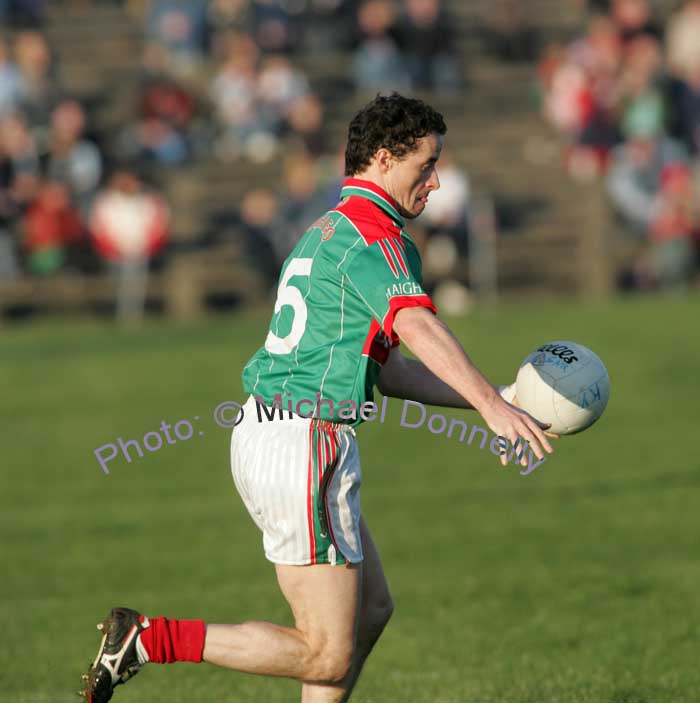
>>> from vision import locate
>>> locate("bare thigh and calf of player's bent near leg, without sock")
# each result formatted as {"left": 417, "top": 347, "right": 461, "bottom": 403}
{"left": 203, "top": 564, "right": 362, "bottom": 684}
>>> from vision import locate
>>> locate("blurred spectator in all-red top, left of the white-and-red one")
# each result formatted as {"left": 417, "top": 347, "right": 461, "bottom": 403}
{"left": 23, "top": 181, "right": 86, "bottom": 274}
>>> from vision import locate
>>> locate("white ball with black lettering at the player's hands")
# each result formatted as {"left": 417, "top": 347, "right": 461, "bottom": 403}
{"left": 515, "top": 342, "right": 610, "bottom": 435}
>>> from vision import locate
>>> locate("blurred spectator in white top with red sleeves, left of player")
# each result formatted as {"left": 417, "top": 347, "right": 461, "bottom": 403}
{"left": 91, "top": 168, "right": 169, "bottom": 323}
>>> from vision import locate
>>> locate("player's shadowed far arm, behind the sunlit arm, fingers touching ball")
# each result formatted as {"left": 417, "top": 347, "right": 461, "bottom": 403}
{"left": 377, "top": 347, "right": 515, "bottom": 410}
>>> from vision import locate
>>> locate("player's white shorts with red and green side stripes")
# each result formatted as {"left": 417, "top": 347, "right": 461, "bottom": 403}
{"left": 231, "top": 396, "right": 362, "bottom": 565}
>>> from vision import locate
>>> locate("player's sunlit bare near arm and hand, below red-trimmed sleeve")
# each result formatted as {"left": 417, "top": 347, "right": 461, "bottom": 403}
{"left": 393, "top": 307, "right": 553, "bottom": 465}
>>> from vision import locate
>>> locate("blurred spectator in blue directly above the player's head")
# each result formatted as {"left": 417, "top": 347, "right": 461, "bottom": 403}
{"left": 352, "top": 0, "right": 412, "bottom": 91}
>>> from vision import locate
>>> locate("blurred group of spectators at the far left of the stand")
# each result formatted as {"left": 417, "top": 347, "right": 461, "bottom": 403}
{"left": 0, "top": 5, "right": 168, "bottom": 279}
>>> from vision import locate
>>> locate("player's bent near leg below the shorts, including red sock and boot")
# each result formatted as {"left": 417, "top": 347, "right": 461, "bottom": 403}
{"left": 82, "top": 564, "right": 362, "bottom": 703}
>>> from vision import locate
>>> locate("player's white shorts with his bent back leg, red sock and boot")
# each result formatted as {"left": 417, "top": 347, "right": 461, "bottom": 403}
{"left": 80, "top": 412, "right": 362, "bottom": 703}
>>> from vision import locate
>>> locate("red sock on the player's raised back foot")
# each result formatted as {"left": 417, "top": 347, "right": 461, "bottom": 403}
{"left": 139, "top": 618, "right": 206, "bottom": 664}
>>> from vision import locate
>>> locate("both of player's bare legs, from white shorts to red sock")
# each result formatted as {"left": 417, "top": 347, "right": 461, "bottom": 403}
{"left": 204, "top": 520, "right": 393, "bottom": 703}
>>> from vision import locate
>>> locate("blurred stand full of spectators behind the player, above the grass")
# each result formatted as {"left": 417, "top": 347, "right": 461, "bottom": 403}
{"left": 0, "top": 0, "right": 700, "bottom": 325}
